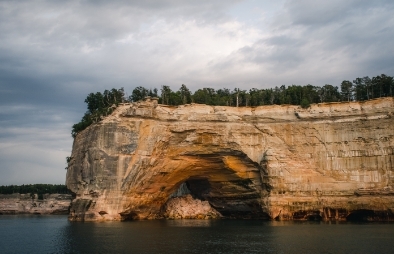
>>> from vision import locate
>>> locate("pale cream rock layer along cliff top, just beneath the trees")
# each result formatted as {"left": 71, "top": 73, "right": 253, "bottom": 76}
{"left": 103, "top": 97, "right": 394, "bottom": 122}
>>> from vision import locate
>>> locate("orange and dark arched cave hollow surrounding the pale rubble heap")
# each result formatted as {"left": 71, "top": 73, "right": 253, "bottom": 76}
{"left": 122, "top": 149, "right": 268, "bottom": 219}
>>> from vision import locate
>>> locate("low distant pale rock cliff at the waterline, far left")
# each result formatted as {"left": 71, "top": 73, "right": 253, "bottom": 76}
{"left": 0, "top": 193, "right": 72, "bottom": 214}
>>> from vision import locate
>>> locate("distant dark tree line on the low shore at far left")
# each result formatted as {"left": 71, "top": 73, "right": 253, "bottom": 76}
{"left": 0, "top": 184, "right": 71, "bottom": 199}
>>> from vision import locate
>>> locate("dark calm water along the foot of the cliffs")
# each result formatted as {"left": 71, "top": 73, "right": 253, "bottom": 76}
{"left": 0, "top": 215, "right": 394, "bottom": 254}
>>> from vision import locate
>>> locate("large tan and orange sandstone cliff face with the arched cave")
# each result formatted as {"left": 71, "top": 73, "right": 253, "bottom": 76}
{"left": 67, "top": 98, "right": 394, "bottom": 220}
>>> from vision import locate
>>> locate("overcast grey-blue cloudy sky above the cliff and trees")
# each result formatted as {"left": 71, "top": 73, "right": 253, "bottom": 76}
{"left": 0, "top": 0, "right": 394, "bottom": 185}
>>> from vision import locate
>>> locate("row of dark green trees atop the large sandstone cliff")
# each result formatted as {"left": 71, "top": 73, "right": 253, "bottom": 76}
{"left": 71, "top": 74, "right": 394, "bottom": 137}
